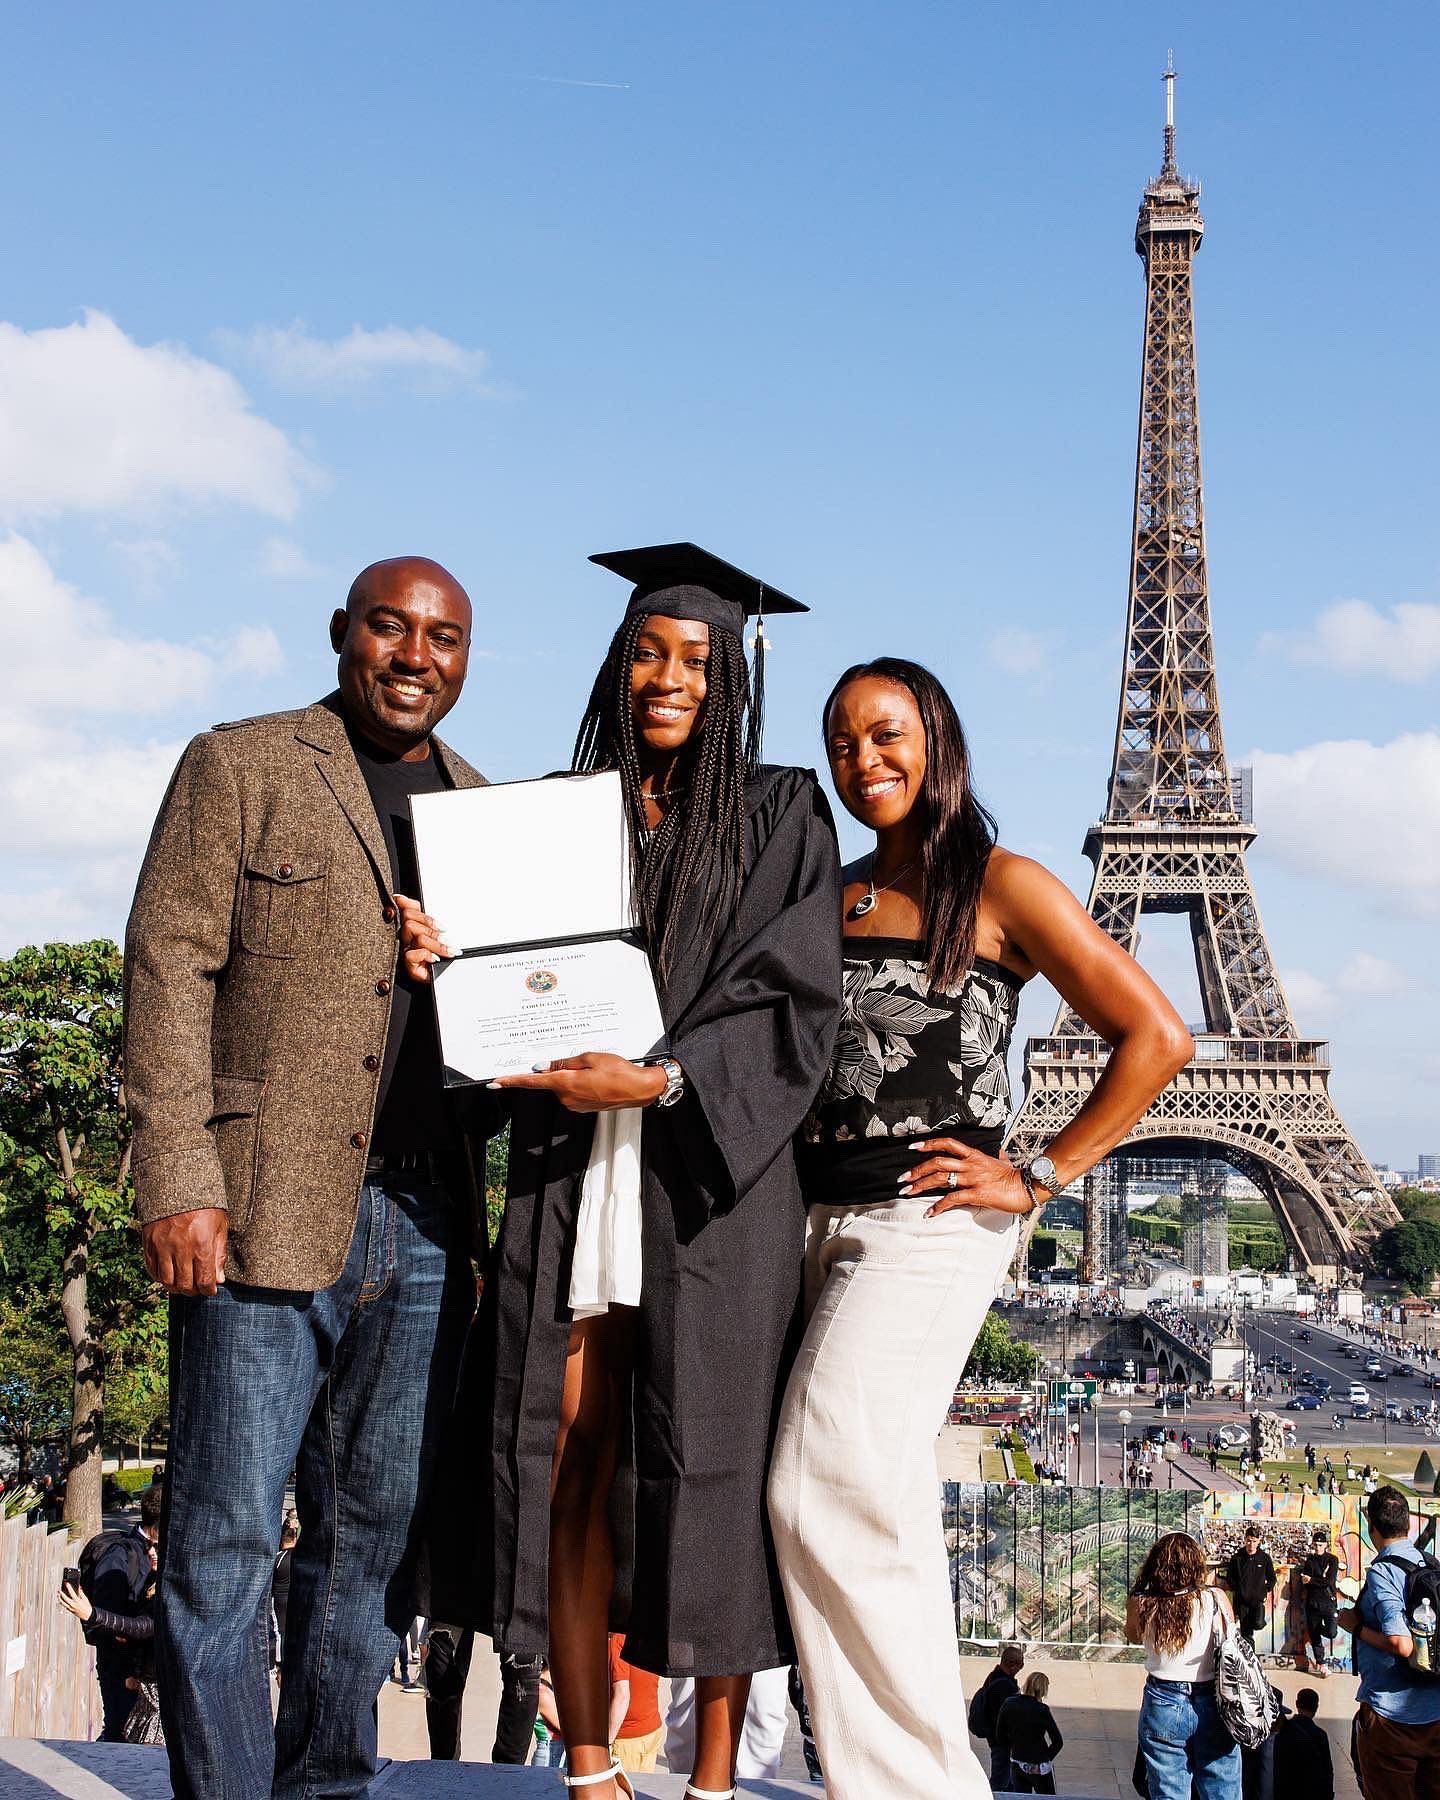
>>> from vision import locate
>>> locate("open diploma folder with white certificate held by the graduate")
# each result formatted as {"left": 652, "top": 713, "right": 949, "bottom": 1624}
{"left": 410, "top": 770, "right": 664, "bottom": 1087}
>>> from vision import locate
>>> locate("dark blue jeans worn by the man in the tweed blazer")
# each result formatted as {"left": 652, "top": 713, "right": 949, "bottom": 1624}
{"left": 157, "top": 1177, "right": 475, "bottom": 1800}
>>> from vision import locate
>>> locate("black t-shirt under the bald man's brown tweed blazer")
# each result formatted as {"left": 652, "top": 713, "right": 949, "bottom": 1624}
{"left": 349, "top": 731, "right": 454, "bottom": 1156}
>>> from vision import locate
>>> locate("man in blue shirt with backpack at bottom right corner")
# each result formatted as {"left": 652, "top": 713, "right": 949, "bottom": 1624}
{"left": 1336, "top": 1485, "right": 1440, "bottom": 1800}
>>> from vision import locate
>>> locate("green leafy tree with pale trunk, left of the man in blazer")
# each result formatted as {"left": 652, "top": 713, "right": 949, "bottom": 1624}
{"left": 0, "top": 940, "right": 158, "bottom": 1535}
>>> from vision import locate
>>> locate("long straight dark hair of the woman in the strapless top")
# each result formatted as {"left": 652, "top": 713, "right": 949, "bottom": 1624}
{"left": 821, "top": 657, "right": 995, "bottom": 994}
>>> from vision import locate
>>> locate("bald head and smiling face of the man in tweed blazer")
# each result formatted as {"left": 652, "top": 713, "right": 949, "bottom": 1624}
{"left": 329, "top": 556, "right": 470, "bottom": 756}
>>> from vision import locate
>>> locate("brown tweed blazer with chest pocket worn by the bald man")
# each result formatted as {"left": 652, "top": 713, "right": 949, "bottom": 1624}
{"left": 124, "top": 695, "right": 484, "bottom": 1291}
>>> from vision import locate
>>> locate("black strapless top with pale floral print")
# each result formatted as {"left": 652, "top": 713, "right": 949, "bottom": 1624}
{"left": 801, "top": 938, "right": 1024, "bottom": 1206}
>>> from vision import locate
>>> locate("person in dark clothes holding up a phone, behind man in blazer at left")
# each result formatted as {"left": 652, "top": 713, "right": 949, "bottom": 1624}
{"left": 59, "top": 1487, "right": 160, "bottom": 1744}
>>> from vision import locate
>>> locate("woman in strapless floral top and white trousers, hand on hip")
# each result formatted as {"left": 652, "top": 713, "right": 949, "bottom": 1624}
{"left": 770, "top": 657, "right": 1192, "bottom": 1800}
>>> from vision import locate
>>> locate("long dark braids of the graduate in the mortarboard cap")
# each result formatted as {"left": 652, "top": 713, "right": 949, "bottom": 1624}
{"left": 571, "top": 612, "right": 760, "bottom": 979}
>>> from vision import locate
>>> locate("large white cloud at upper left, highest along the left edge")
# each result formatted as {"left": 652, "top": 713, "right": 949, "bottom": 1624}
{"left": 0, "top": 311, "right": 313, "bottom": 524}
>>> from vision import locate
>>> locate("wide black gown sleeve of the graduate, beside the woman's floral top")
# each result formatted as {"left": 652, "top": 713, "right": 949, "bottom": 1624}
{"left": 652, "top": 769, "right": 841, "bottom": 1211}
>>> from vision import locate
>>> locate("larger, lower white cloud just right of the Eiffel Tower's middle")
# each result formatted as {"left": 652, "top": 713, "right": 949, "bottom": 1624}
{"left": 1249, "top": 731, "right": 1440, "bottom": 914}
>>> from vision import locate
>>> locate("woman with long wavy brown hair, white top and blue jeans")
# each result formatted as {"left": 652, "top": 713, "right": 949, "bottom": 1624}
{"left": 1125, "top": 1532, "right": 1240, "bottom": 1800}
